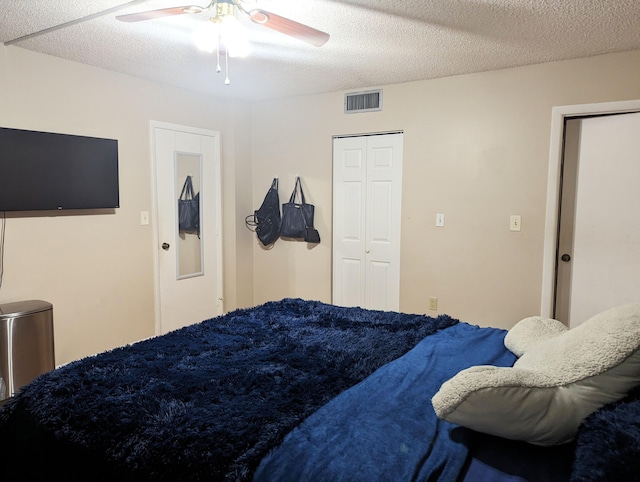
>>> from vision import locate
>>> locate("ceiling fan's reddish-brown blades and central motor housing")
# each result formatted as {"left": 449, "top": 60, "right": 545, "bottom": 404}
{"left": 116, "top": 0, "right": 329, "bottom": 47}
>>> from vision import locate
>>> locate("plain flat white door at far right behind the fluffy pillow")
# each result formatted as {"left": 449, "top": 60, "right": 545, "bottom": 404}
{"left": 569, "top": 113, "right": 640, "bottom": 326}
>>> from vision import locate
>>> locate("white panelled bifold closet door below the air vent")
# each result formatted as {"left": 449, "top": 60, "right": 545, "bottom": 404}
{"left": 333, "top": 133, "right": 403, "bottom": 311}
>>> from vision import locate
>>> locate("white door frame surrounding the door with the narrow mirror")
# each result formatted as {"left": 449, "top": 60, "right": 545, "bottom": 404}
{"left": 149, "top": 120, "right": 224, "bottom": 335}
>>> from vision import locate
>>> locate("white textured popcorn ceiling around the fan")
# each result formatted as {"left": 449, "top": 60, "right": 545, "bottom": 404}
{"left": 0, "top": 0, "right": 640, "bottom": 99}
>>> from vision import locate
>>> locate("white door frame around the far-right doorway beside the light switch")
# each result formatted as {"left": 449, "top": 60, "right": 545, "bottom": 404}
{"left": 540, "top": 99, "right": 640, "bottom": 317}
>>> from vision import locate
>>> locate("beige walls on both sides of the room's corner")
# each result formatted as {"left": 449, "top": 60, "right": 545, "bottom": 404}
{"left": 0, "top": 47, "right": 640, "bottom": 363}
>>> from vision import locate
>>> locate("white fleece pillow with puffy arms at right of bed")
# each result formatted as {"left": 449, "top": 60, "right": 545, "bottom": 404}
{"left": 432, "top": 304, "right": 640, "bottom": 445}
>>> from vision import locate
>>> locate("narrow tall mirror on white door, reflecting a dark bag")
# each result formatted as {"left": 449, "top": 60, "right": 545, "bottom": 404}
{"left": 174, "top": 152, "right": 204, "bottom": 279}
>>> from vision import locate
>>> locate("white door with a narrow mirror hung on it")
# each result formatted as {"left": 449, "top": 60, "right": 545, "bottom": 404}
{"left": 151, "top": 122, "right": 223, "bottom": 334}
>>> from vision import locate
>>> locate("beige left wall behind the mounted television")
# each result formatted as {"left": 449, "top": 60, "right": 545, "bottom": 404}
{"left": 0, "top": 47, "right": 253, "bottom": 364}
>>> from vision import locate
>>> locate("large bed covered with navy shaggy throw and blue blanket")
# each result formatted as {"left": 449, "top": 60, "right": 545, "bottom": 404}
{"left": 0, "top": 298, "right": 640, "bottom": 482}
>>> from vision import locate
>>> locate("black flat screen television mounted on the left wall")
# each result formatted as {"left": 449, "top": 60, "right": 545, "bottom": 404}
{"left": 0, "top": 128, "right": 120, "bottom": 212}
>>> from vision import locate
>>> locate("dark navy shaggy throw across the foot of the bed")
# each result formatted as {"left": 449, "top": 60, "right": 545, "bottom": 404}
{"left": 0, "top": 299, "right": 457, "bottom": 482}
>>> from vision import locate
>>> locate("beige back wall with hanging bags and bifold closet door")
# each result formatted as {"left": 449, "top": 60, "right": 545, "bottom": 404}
{"left": 253, "top": 51, "right": 640, "bottom": 328}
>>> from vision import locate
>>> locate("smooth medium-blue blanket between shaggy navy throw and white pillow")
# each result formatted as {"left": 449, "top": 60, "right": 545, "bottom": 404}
{"left": 254, "top": 323, "right": 515, "bottom": 482}
